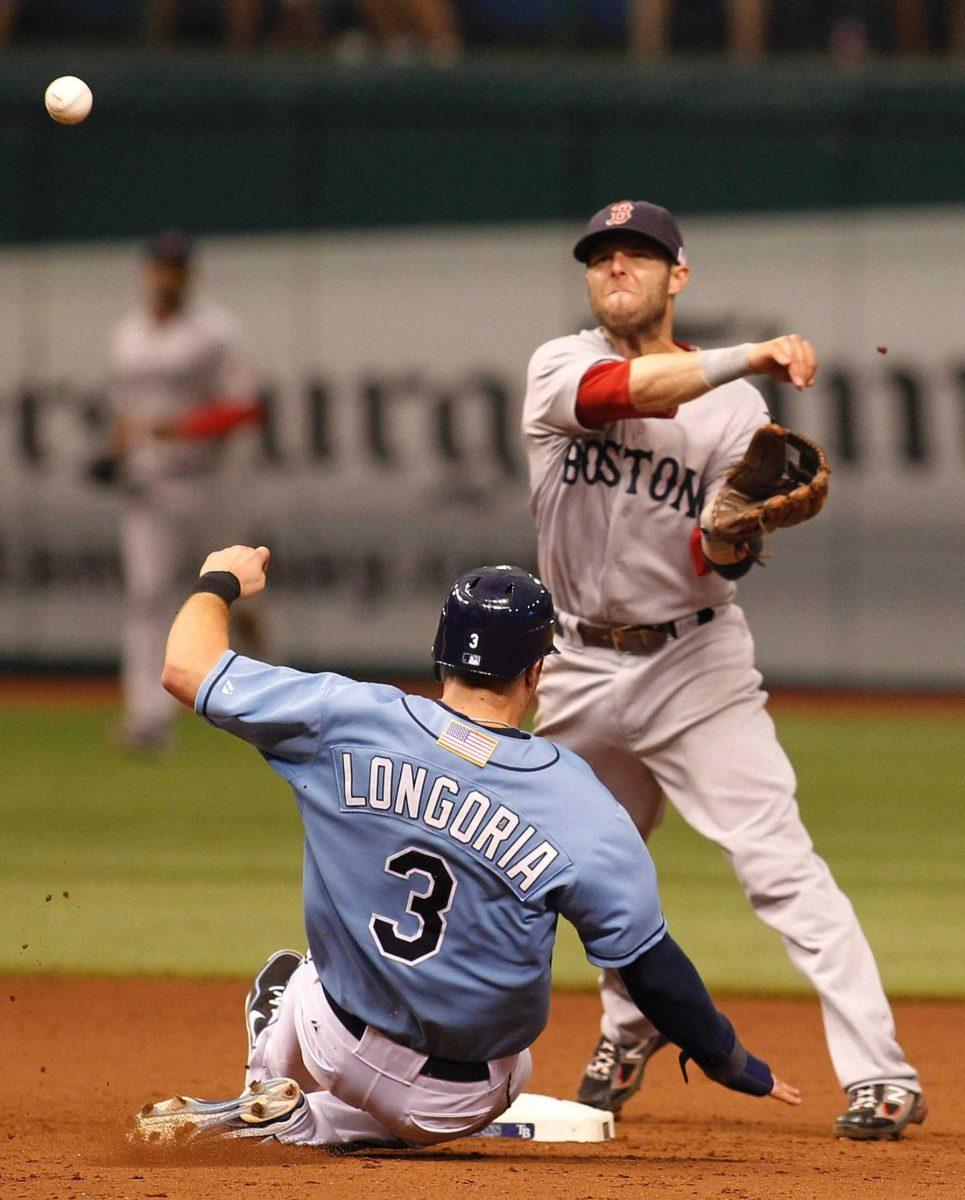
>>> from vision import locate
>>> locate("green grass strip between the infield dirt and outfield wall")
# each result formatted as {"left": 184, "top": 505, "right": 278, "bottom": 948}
{"left": 0, "top": 709, "right": 965, "bottom": 996}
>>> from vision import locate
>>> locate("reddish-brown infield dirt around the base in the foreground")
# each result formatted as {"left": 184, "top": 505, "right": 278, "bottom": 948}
{"left": 0, "top": 977, "right": 965, "bottom": 1200}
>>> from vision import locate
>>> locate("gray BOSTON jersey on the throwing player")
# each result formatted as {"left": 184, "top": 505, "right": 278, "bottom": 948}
{"left": 523, "top": 329, "right": 771, "bottom": 625}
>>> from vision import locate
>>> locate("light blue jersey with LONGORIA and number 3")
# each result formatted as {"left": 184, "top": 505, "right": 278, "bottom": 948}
{"left": 196, "top": 650, "right": 666, "bottom": 1062}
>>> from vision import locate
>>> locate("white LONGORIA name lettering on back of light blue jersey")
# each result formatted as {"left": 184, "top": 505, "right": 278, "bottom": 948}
{"left": 332, "top": 746, "right": 569, "bottom": 895}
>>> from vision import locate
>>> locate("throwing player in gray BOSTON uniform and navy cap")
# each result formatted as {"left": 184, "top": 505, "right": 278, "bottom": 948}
{"left": 523, "top": 200, "right": 925, "bottom": 1139}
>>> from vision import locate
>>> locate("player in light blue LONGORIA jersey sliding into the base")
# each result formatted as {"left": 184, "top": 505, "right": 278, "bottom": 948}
{"left": 133, "top": 546, "right": 799, "bottom": 1146}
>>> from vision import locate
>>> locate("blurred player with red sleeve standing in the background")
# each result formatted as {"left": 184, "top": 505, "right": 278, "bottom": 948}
{"left": 110, "top": 232, "right": 262, "bottom": 750}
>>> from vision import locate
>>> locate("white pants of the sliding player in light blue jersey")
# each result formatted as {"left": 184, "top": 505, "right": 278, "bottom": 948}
{"left": 245, "top": 960, "right": 532, "bottom": 1146}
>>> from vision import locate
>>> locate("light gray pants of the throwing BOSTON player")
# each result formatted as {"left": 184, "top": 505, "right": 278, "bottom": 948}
{"left": 537, "top": 605, "right": 918, "bottom": 1088}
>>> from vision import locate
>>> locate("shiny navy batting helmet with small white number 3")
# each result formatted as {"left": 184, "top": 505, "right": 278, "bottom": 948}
{"left": 432, "top": 566, "right": 559, "bottom": 679}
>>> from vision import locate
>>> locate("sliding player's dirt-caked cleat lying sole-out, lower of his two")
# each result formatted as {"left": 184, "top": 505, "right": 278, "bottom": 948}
{"left": 136, "top": 1079, "right": 307, "bottom": 1142}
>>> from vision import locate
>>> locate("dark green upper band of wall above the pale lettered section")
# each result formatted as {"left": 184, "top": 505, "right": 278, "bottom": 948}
{"left": 0, "top": 49, "right": 965, "bottom": 242}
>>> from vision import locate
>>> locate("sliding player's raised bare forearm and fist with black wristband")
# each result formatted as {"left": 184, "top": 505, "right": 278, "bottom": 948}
{"left": 161, "top": 546, "right": 270, "bottom": 707}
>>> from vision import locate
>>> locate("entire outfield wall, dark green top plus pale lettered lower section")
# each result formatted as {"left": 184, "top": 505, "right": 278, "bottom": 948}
{"left": 0, "top": 49, "right": 965, "bottom": 686}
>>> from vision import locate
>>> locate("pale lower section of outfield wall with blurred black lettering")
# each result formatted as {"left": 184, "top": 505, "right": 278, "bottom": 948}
{"left": 0, "top": 209, "right": 965, "bottom": 688}
